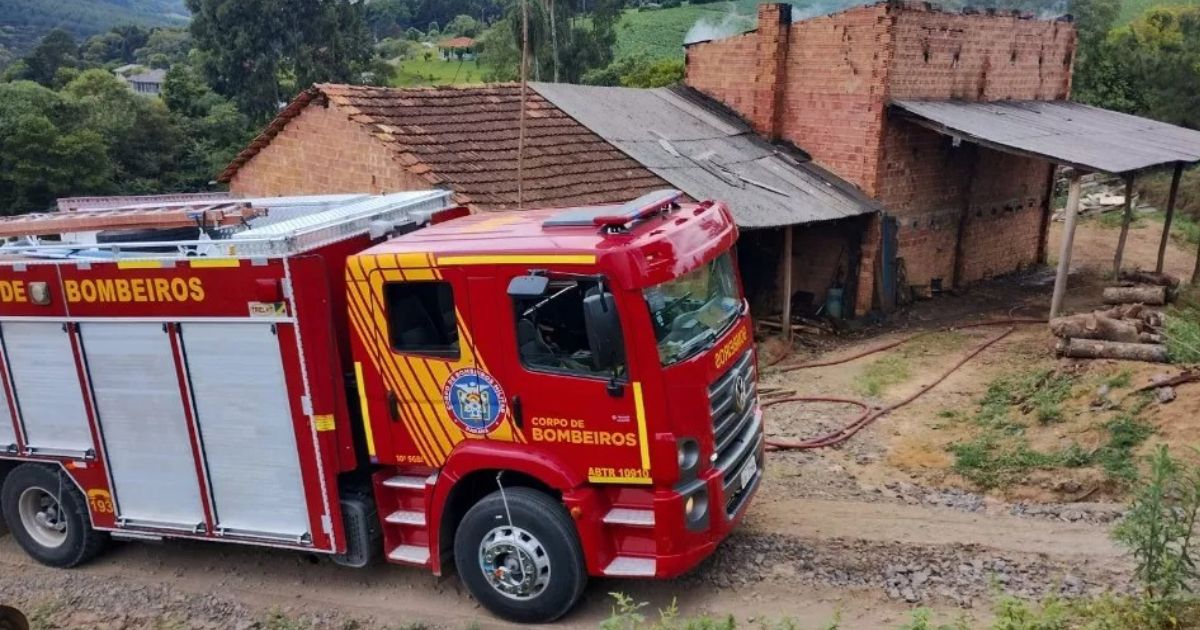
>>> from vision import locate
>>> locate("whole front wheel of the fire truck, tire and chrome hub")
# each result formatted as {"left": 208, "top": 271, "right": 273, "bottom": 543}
{"left": 454, "top": 487, "right": 588, "bottom": 623}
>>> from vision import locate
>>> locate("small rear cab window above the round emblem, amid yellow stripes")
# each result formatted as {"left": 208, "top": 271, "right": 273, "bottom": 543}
{"left": 383, "top": 282, "right": 458, "bottom": 359}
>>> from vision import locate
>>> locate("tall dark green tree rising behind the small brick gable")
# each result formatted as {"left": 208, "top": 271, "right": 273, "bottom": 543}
{"left": 186, "top": 0, "right": 372, "bottom": 121}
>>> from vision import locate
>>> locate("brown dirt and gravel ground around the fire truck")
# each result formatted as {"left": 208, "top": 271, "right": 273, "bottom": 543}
{"left": 0, "top": 218, "right": 1200, "bottom": 630}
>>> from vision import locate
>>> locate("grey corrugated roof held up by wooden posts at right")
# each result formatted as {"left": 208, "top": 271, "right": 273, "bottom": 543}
{"left": 892, "top": 101, "right": 1200, "bottom": 173}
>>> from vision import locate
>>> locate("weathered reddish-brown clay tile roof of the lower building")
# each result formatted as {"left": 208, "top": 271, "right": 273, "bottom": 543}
{"left": 218, "top": 84, "right": 670, "bottom": 210}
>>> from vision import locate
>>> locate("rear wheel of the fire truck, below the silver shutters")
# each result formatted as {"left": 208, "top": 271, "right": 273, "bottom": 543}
{"left": 0, "top": 463, "right": 108, "bottom": 569}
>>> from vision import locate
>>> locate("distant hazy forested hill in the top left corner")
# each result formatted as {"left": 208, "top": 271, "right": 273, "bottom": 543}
{"left": 0, "top": 0, "right": 187, "bottom": 66}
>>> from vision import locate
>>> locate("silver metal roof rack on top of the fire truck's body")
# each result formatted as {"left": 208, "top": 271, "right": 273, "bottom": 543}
{"left": 0, "top": 191, "right": 451, "bottom": 262}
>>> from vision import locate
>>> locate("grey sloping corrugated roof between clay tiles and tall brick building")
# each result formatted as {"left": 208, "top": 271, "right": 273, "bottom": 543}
{"left": 533, "top": 83, "right": 880, "bottom": 228}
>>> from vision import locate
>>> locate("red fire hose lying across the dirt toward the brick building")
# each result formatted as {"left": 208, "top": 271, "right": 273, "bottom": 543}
{"left": 762, "top": 318, "right": 1046, "bottom": 450}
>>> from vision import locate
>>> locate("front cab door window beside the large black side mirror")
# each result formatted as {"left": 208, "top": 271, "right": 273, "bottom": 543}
{"left": 512, "top": 280, "right": 625, "bottom": 378}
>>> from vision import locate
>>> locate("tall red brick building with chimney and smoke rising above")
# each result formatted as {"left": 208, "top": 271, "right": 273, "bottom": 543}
{"left": 686, "top": 1, "right": 1075, "bottom": 299}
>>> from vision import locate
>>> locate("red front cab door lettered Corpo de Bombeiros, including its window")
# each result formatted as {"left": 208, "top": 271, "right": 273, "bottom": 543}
{"left": 470, "top": 266, "right": 650, "bottom": 484}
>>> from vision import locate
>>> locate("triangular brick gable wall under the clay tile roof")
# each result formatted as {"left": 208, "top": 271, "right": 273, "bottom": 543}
{"left": 229, "top": 102, "right": 432, "bottom": 197}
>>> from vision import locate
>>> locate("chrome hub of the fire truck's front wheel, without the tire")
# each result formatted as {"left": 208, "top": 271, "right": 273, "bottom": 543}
{"left": 479, "top": 526, "right": 550, "bottom": 600}
